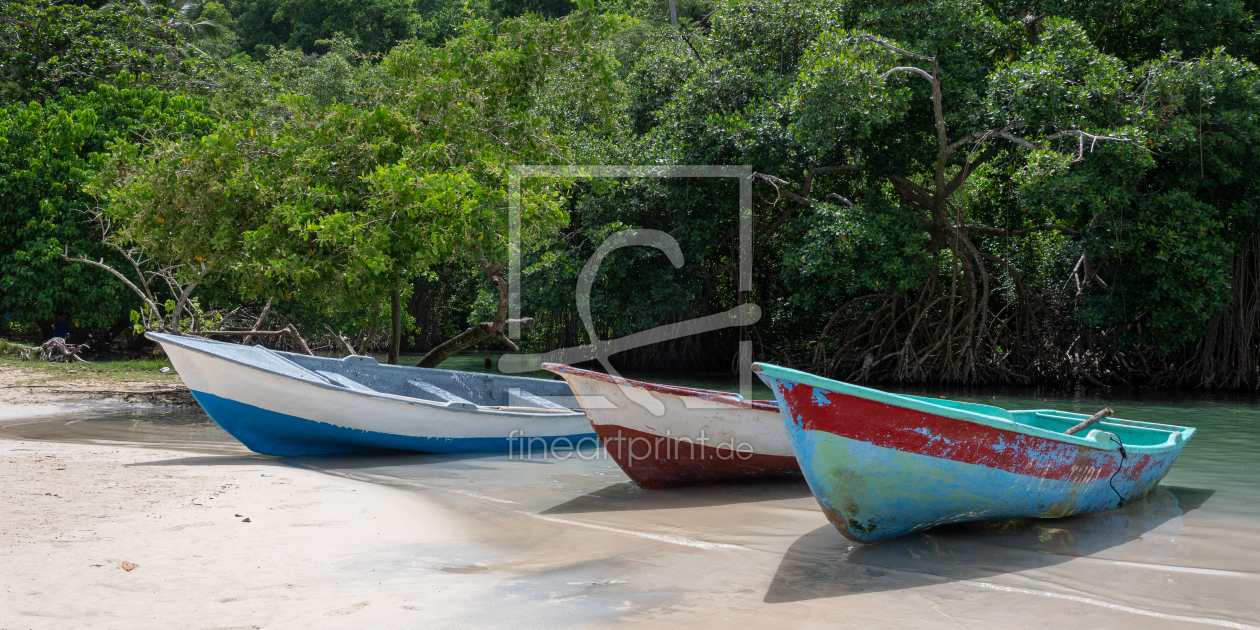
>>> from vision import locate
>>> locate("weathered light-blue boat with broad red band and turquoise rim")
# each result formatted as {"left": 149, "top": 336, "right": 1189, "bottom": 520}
{"left": 752, "top": 363, "right": 1194, "bottom": 543}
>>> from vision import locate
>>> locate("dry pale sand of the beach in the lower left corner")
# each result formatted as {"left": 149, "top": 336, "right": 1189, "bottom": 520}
{"left": 0, "top": 441, "right": 478, "bottom": 629}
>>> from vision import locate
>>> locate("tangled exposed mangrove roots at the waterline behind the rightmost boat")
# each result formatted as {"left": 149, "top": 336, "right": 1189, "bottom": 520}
{"left": 806, "top": 237, "right": 1260, "bottom": 391}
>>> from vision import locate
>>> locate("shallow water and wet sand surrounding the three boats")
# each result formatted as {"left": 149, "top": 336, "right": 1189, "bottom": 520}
{"left": 0, "top": 355, "right": 1260, "bottom": 629}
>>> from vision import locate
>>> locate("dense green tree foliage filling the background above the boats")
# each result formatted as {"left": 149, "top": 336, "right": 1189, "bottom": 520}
{"left": 9, "top": 0, "right": 1260, "bottom": 375}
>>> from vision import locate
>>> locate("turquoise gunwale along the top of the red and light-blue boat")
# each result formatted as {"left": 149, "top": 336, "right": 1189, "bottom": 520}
{"left": 752, "top": 363, "right": 1196, "bottom": 455}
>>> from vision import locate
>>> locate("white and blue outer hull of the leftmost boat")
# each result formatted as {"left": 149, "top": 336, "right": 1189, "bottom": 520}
{"left": 154, "top": 335, "right": 595, "bottom": 456}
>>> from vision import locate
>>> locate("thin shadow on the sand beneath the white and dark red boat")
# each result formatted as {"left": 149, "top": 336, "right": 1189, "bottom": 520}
{"left": 542, "top": 479, "right": 810, "bottom": 514}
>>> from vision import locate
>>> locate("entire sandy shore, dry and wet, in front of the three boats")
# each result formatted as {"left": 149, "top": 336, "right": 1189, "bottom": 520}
{"left": 0, "top": 400, "right": 1260, "bottom": 629}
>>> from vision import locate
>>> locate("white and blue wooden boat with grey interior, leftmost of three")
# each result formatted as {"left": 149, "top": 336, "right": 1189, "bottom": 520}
{"left": 146, "top": 333, "right": 595, "bottom": 456}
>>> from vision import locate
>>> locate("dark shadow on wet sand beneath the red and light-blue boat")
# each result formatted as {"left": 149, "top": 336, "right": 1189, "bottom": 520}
{"left": 764, "top": 486, "right": 1215, "bottom": 604}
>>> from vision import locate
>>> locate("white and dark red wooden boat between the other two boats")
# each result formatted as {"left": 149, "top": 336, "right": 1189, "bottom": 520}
{"left": 543, "top": 363, "right": 800, "bottom": 488}
